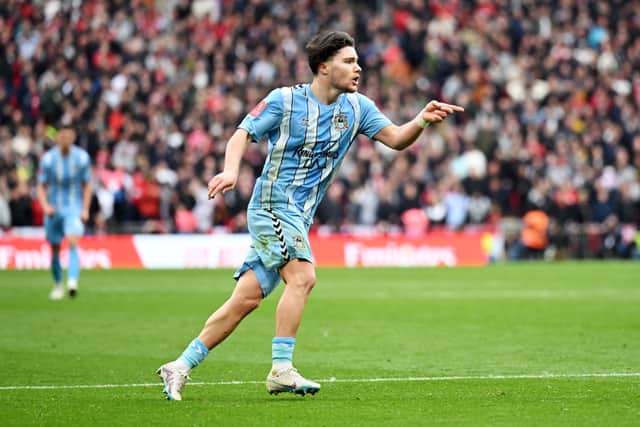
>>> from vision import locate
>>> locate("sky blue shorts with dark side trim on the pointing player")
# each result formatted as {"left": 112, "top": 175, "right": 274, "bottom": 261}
{"left": 233, "top": 208, "right": 314, "bottom": 298}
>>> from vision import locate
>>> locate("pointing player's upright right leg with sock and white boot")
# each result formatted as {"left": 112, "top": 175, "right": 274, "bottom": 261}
{"left": 267, "top": 259, "right": 320, "bottom": 395}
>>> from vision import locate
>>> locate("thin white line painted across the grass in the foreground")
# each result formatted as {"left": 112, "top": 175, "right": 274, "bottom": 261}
{"left": 0, "top": 372, "right": 640, "bottom": 391}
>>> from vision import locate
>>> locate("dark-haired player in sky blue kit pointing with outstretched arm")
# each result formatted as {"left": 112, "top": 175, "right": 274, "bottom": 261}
{"left": 158, "top": 31, "right": 464, "bottom": 400}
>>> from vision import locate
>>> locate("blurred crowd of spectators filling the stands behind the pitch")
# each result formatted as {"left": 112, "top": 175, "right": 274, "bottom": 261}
{"left": 0, "top": 0, "right": 640, "bottom": 256}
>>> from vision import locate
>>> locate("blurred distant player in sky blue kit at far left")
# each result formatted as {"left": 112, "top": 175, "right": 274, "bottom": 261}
{"left": 37, "top": 126, "right": 91, "bottom": 300}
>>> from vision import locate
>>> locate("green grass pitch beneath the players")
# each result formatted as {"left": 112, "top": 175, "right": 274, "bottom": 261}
{"left": 0, "top": 262, "right": 640, "bottom": 426}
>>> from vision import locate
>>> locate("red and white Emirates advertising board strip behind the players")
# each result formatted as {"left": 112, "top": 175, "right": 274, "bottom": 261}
{"left": 0, "top": 232, "right": 491, "bottom": 269}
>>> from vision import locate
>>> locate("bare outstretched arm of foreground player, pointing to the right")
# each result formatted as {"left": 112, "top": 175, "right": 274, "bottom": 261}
{"left": 374, "top": 101, "right": 464, "bottom": 150}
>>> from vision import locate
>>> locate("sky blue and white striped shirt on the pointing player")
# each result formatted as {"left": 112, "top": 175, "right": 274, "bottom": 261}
{"left": 238, "top": 84, "right": 391, "bottom": 224}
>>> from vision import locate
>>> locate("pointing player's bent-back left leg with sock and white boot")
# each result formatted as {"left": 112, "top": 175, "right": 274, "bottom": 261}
{"left": 158, "top": 270, "right": 262, "bottom": 400}
